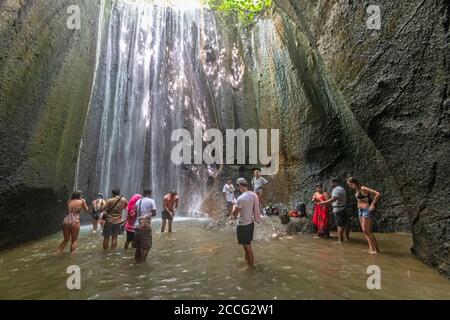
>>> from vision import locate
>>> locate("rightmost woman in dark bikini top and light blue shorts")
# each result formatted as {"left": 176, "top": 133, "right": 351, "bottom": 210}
{"left": 347, "top": 177, "right": 381, "bottom": 253}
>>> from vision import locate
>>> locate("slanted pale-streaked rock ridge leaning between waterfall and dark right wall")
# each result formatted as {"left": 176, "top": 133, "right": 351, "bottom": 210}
{"left": 249, "top": 8, "right": 410, "bottom": 232}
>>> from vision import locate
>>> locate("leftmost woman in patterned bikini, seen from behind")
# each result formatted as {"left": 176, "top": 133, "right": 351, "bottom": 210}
{"left": 55, "top": 191, "right": 89, "bottom": 254}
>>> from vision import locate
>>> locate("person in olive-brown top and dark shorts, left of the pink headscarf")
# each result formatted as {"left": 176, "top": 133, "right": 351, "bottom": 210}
{"left": 100, "top": 189, "right": 128, "bottom": 250}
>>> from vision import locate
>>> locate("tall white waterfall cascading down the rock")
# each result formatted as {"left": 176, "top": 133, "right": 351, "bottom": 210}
{"left": 77, "top": 1, "right": 250, "bottom": 212}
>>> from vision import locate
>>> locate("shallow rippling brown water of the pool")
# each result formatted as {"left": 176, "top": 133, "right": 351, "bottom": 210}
{"left": 0, "top": 219, "right": 450, "bottom": 299}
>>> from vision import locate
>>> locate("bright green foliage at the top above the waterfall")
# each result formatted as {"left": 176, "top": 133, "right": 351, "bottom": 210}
{"left": 204, "top": 0, "right": 273, "bottom": 25}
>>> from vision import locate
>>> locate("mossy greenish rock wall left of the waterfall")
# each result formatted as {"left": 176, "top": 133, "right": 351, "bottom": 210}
{"left": 0, "top": 0, "right": 98, "bottom": 248}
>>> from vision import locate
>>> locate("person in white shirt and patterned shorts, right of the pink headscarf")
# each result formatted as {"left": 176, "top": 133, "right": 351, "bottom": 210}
{"left": 134, "top": 189, "right": 156, "bottom": 262}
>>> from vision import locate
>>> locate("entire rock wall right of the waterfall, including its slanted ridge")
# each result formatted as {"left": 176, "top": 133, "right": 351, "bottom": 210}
{"left": 260, "top": 0, "right": 450, "bottom": 274}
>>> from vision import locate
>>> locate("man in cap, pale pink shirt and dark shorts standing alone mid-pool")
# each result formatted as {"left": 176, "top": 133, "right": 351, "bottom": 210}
{"left": 233, "top": 178, "right": 261, "bottom": 268}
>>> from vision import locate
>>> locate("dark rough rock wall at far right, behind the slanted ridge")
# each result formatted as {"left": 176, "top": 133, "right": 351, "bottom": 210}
{"left": 270, "top": 0, "right": 450, "bottom": 275}
